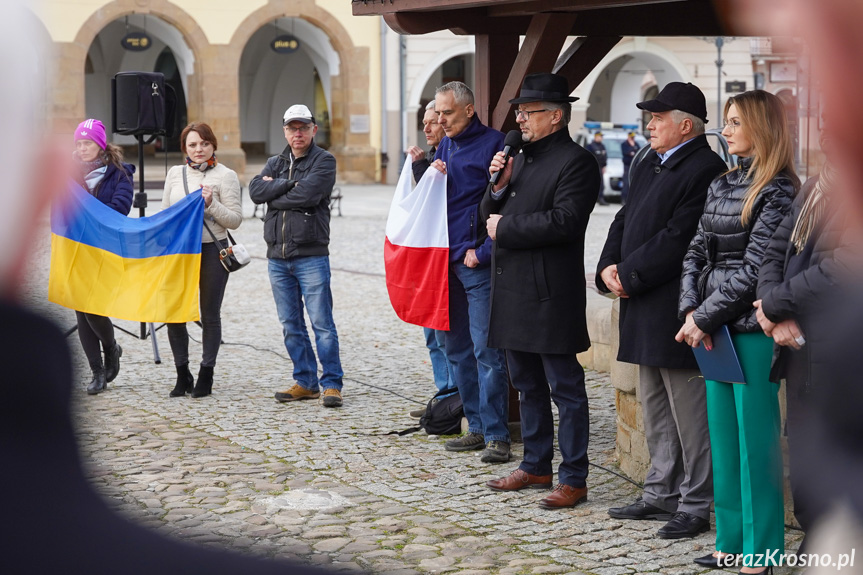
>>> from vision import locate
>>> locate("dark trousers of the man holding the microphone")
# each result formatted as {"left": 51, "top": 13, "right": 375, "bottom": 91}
{"left": 506, "top": 350, "right": 590, "bottom": 487}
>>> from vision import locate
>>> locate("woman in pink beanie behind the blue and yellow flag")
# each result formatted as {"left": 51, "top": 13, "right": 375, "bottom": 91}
{"left": 73, "top": 119, "right": 135, "bottom": 395}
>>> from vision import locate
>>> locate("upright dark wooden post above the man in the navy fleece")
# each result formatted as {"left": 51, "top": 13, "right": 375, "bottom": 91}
{"left": 473, "top": 34, "right": 519, "bottom": 126}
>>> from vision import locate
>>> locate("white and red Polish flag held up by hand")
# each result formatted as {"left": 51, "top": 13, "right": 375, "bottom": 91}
{"left": 384, "top": 156, "right": 449, "bottom": 330}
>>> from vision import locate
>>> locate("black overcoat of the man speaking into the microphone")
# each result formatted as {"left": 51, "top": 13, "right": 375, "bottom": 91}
{"left": 480, "top": 129, "right": 601, "bottom": 354}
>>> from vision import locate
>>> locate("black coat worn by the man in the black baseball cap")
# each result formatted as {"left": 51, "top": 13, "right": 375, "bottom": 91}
{"left": 596, "top": 136, "right": 727, "bottom": 369}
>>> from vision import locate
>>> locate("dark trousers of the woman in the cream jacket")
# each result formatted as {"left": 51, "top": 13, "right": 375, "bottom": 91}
{"left": 168, "top": 242, "right": 229, "bottom": 367}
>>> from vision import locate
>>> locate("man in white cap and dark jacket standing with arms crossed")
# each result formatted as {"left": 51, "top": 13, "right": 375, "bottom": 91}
{"left": 249, "top": 104, "right": 343, "bottom": 407}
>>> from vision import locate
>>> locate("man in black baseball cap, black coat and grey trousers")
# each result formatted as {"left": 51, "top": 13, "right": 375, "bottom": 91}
{"left": 596, "top": 82, "right": 726, "bottom": 539}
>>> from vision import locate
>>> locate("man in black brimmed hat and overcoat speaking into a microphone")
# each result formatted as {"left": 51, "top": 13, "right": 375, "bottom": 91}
{"left": 480, "top": 74, "right": 601, "bottom": 509}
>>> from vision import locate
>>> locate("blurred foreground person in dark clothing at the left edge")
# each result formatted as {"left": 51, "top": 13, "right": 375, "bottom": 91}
{"left": 0, "top": 0, "right": 330, "bottom": 575}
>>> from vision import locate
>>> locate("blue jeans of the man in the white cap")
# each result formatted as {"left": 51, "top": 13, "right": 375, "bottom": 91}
{"left": 269, "top": 256, "right": 344, "bottom": 391}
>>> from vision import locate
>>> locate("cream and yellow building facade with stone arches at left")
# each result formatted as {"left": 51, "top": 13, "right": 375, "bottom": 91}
{"left": 32, "top": 0, "right": 382, "bottom": 183}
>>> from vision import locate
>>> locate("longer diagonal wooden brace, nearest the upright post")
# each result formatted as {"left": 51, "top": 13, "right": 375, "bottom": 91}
{"left": 490, "top": 14, "right": 576, "bottom": 130}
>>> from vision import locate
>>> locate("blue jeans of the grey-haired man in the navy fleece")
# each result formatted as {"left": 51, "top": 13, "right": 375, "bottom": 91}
{"left": 445, "top": 262, "right": 509, "bottom": 443}
